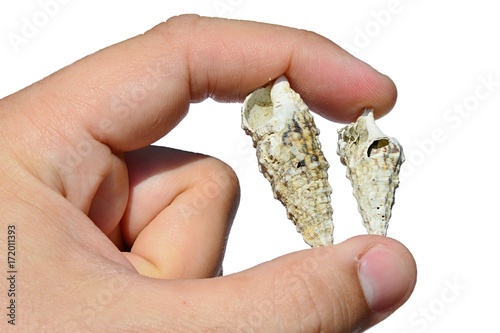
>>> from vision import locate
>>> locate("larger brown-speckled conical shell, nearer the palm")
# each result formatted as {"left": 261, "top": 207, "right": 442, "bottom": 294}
{"left": 242, "top": 76, "right": 333, "bottom": 247}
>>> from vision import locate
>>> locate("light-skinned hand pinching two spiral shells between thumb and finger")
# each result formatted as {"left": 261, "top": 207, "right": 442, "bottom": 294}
{"left": 0, "top": 16, "right": 416, "bottom": 332}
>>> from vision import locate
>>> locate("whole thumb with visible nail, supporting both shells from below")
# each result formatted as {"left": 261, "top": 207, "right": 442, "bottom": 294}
{"left": 129, "top": 236, "right": 416, "bottom": 332}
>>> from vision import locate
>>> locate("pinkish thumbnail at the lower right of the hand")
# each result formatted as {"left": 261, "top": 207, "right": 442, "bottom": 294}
{"left": 358, "top": 246, "right": 410, "bottom": 312}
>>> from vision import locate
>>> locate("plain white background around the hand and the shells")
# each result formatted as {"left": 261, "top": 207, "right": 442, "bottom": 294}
{"left": 0, "top": 0, "right": 500, "bottom": 333}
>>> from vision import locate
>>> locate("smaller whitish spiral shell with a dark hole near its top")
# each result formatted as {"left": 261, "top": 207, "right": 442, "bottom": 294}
{"left": 337, "top": 109, "right": 405, "bottom": 236}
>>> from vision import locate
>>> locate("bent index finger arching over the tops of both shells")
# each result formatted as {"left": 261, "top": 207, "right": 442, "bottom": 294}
{"left": 2, "top": 15, "right": 396, "bottom": 151}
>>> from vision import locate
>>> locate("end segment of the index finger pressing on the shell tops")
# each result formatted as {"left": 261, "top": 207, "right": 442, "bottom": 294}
{"left": 291, "top": 46, "right": 397, "bottom": 123}
